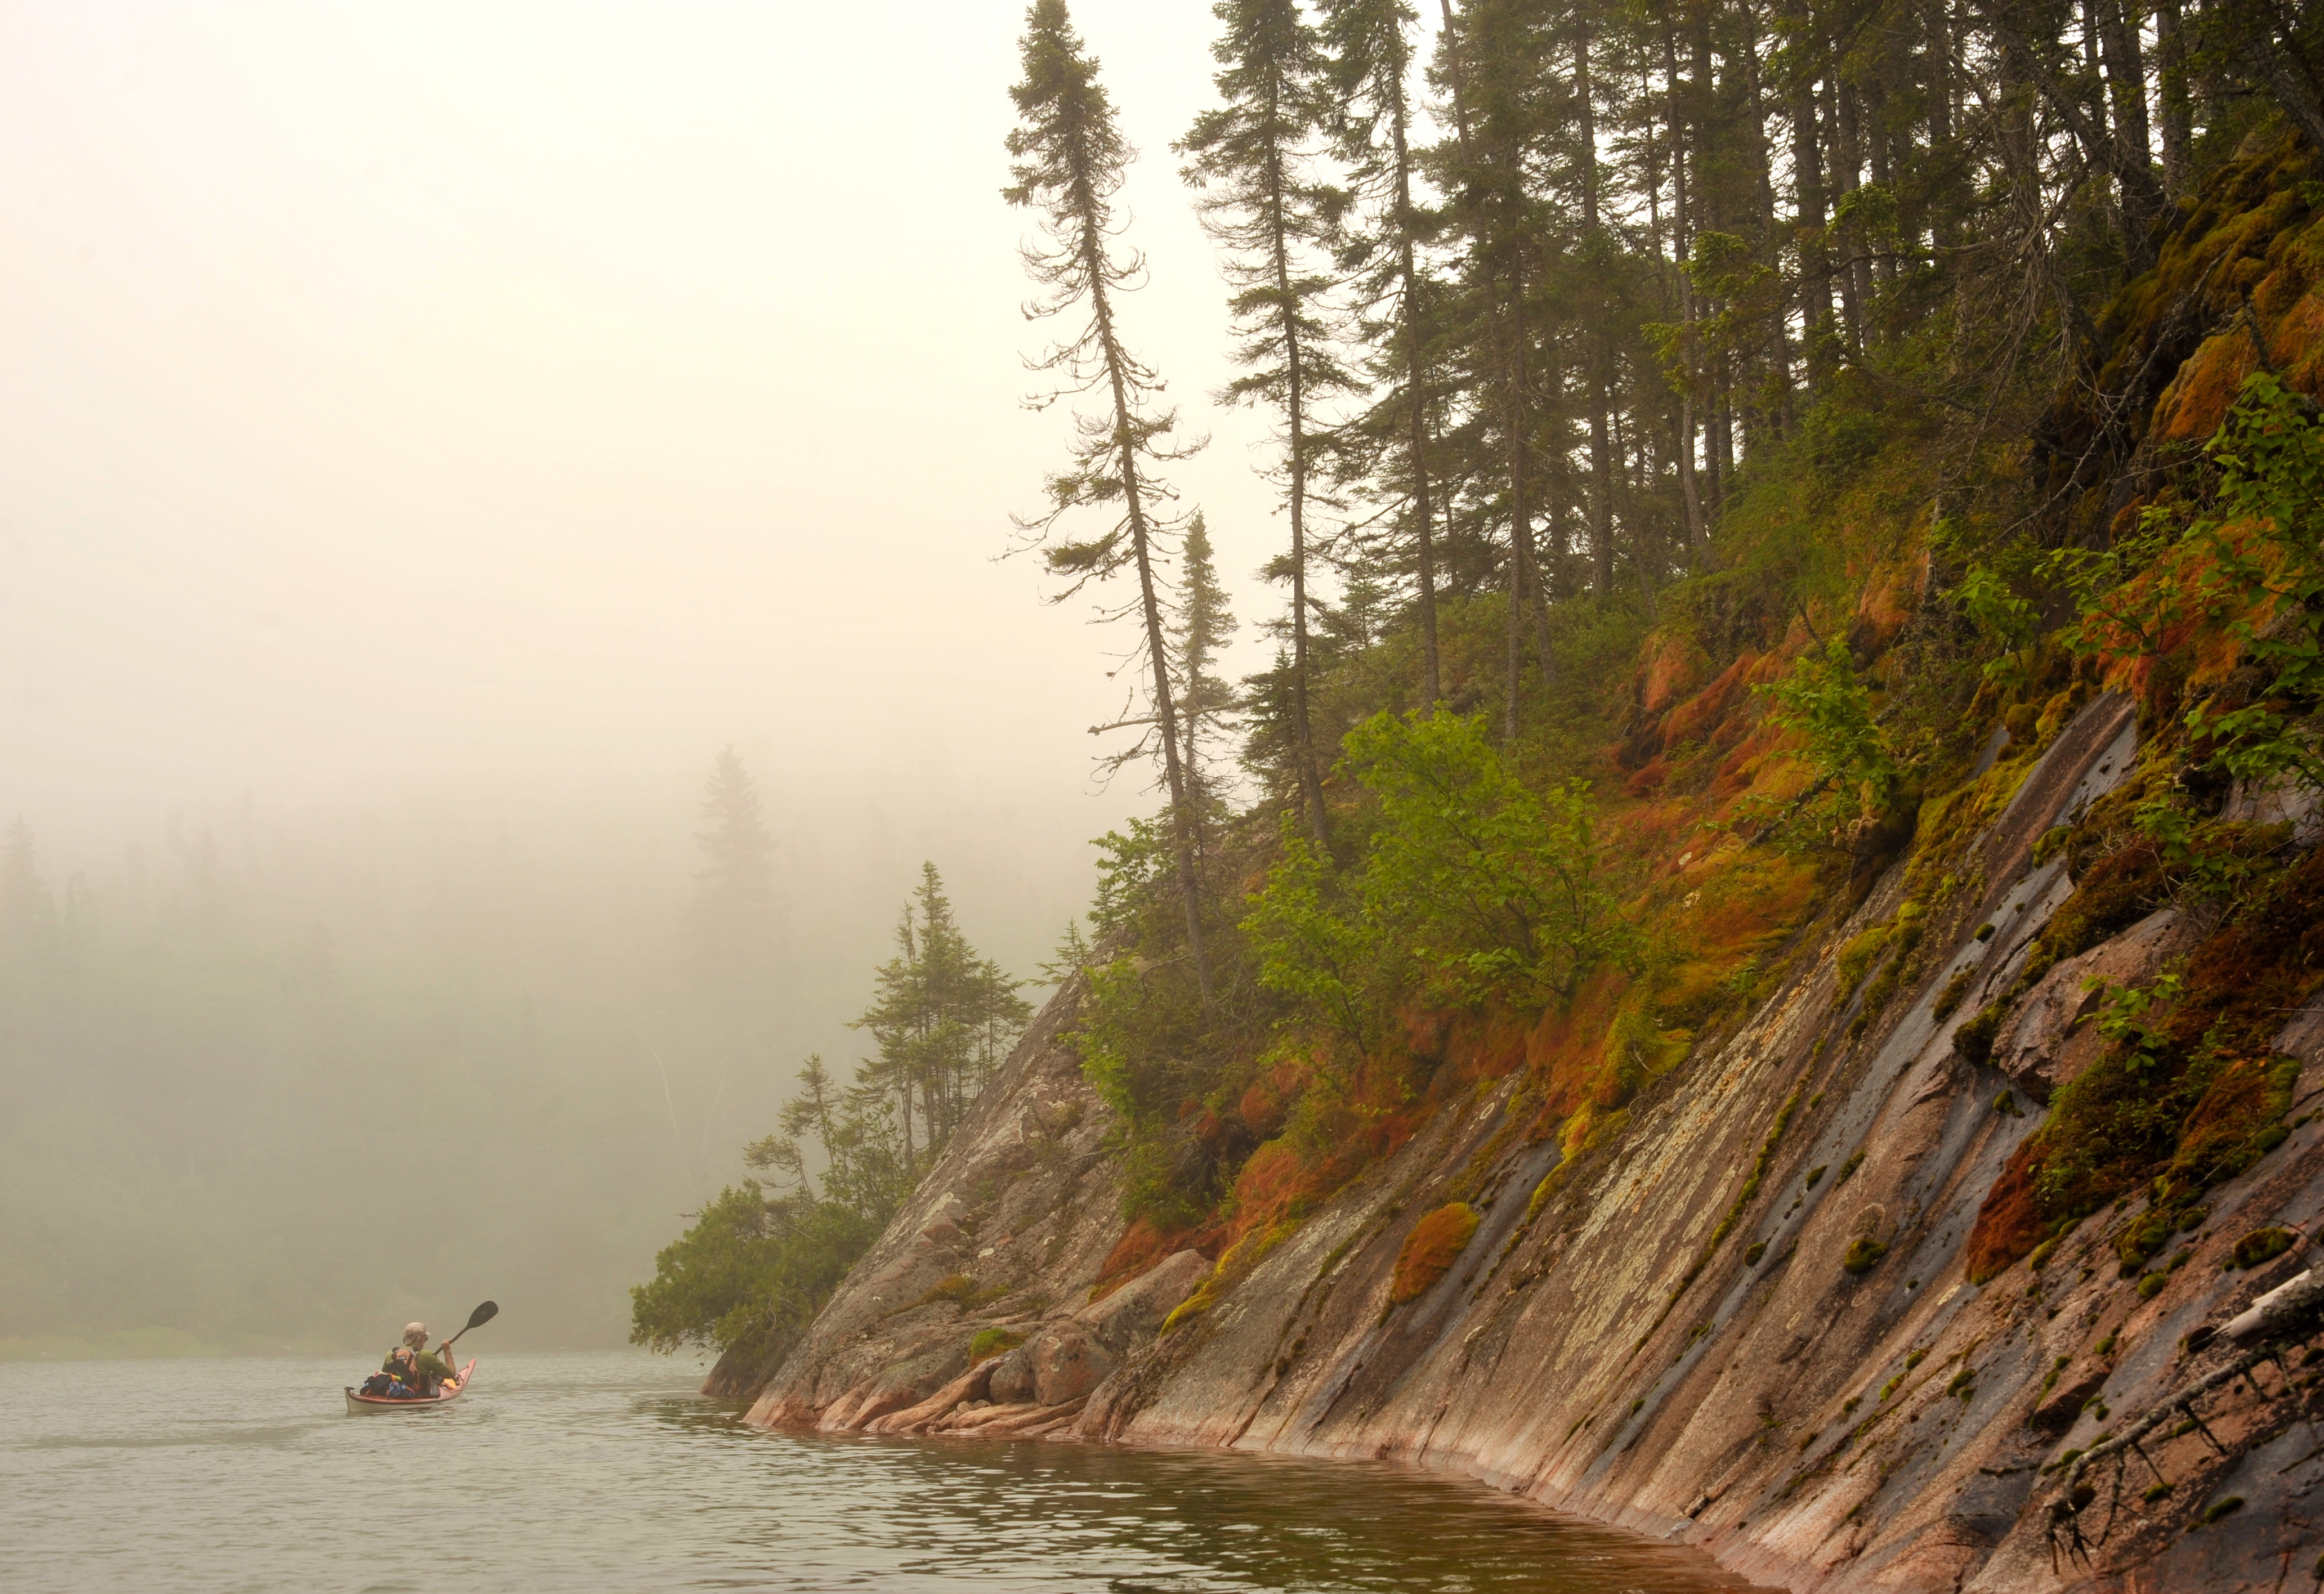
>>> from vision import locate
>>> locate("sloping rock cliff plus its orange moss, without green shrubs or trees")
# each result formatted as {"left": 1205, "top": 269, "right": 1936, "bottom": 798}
{"left": 713, "top": 146, "right": 2324, "bottom": 1592}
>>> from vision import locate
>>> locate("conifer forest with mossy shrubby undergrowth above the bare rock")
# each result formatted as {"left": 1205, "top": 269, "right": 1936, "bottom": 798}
{"left": 985, "top": 0, "right": 2324, "bottom": 1264}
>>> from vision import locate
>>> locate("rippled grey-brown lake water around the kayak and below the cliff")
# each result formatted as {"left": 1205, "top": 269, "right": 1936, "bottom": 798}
{"left": 0, "top": 1347, "right": 1745, "bottom": 1594}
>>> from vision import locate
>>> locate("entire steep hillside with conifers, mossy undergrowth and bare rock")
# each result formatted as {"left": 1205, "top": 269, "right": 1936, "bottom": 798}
{"left": 697, "top": 0, "right": 2324, "bottom": 1589}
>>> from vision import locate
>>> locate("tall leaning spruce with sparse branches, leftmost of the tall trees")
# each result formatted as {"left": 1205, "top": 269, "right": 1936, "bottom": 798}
{"left": 1002, "top": 0, "right": 1211, "bottom": 1009}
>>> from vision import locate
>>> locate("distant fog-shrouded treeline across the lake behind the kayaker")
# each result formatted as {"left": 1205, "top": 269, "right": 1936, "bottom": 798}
{"left": 0, "top": 753, "right": 1069, "bottom": 1355}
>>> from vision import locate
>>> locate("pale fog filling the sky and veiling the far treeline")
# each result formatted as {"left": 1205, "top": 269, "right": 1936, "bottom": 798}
{"left": 0, "top": 0, "right": 1394, "bottom": 1355}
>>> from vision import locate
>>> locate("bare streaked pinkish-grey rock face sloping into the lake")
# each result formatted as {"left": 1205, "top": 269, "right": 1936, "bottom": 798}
{"left": 750, "top": 695, "right": 2324, "bottom": 1592}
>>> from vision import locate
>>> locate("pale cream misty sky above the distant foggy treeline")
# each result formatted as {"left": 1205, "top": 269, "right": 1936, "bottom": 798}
{"left": 0, "top": 0, "right": 1431, "bottom": 888}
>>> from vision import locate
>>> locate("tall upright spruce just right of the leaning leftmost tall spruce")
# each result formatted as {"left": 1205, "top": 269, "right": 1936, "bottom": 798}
{"left": 1176, "top": 0, "right": 1355, "bottom": 850}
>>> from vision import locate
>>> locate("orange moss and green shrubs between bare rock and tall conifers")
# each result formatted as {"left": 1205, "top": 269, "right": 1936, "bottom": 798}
{"left": 1076, "top": 134, "right": 2324, "bottom": 1313}
